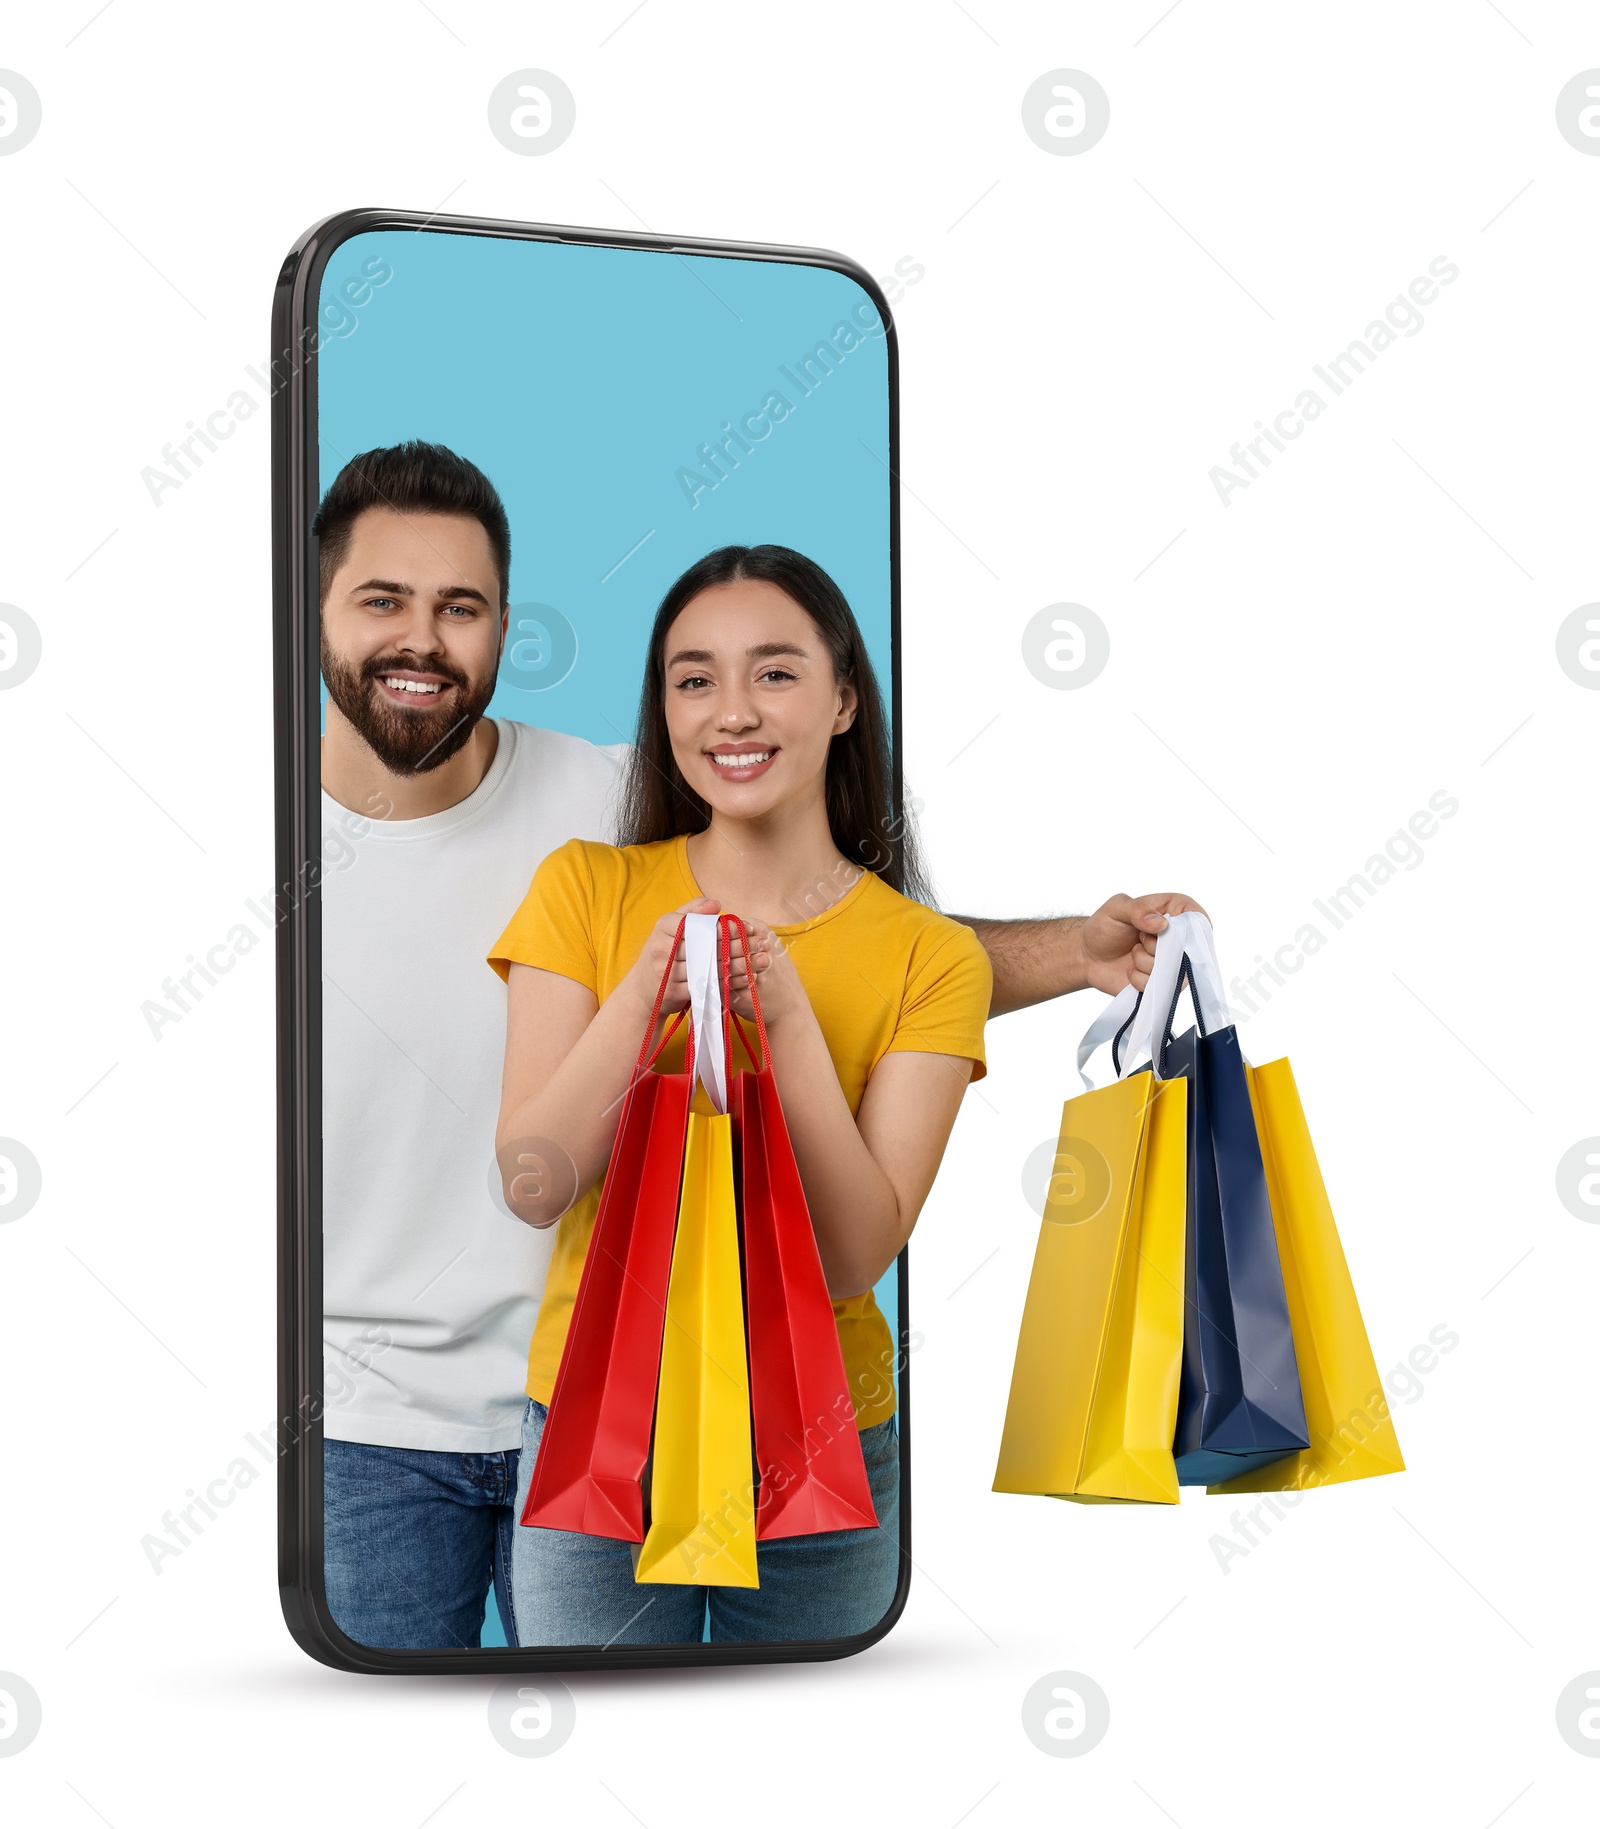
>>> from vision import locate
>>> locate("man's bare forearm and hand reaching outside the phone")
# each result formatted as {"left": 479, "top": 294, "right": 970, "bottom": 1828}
{"left": 951, "top": 894, "right": 1205, "bottom": 1017}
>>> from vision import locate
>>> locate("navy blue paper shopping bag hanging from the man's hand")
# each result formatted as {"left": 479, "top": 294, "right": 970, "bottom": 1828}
{"left": 1126, "top": 913, "right": 1309, "bottom": 1485}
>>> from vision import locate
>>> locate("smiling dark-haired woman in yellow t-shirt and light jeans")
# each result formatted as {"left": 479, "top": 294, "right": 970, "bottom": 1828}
{"left": 490, "top": 547, "right": 991, "bottom": 1644}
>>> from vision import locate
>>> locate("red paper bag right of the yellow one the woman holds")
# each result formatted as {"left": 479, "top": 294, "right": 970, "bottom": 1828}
{"left": 722, "top": 916, "right": 878, "bottom": 1542}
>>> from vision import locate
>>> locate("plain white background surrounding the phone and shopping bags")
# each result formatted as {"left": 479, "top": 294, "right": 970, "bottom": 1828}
{"left": 0, "top": 0, "right": 1600, "bottom": 1829}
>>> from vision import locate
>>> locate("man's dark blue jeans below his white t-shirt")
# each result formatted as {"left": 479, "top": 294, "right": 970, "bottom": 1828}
{"left": 322, "top": 1441, "right": 517, "bottom": 1650}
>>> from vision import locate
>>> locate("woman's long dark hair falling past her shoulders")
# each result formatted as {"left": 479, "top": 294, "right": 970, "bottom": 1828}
{"left": 618, "top": 547, "right": 931, "bottom": 902}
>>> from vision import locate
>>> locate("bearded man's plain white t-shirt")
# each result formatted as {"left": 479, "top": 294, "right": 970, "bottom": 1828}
{"left": 322, "top": 719, "right": 625, "bottom": 1454}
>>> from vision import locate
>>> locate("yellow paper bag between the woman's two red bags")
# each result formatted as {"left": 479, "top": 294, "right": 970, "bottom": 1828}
{"left": 635, "top": 1112, "right": 761, "bottom": 1588}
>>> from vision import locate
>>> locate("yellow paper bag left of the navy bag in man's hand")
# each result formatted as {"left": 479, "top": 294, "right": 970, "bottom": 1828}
{"left": 995, "top": 1072, "right": 1189, "bottom": 1505}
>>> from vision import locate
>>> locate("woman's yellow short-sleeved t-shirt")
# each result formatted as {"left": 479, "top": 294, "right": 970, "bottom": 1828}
{"left": 488, "top": 838, "right": 991, "bottom": 1428}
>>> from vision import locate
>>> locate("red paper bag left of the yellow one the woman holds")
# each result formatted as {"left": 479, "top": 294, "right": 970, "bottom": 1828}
{"left": 521, "top": 927, "right": 695, "bottom": 1544}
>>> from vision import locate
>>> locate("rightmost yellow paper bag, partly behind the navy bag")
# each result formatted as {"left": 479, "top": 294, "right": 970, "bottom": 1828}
{"left": 1207, "top": 1061, "right": 1406, "bottom": 1492}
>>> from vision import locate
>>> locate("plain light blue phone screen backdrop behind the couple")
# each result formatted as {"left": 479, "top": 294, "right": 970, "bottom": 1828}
{"left": 318, "top": 230, "right": 898, "bottom": 1644}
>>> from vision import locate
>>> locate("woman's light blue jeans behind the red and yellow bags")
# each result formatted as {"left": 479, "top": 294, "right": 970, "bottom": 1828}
{"left": 512, "top": 1401, "right": 900, "bottom": 1644}
